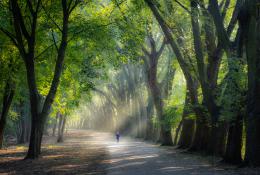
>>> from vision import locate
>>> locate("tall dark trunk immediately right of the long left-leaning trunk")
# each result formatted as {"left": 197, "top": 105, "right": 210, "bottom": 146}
{"left": 191, "top": 0, "right": 223, "bottom": 154}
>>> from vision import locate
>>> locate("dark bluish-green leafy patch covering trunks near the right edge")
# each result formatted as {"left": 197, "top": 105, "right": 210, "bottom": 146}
{"left": 218, "top": 58, "right": 247, "bottom": 121}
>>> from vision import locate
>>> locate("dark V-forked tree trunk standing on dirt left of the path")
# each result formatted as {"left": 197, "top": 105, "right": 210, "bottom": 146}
{"left": 26, "top": 1, "right": 70, "bottom": 159}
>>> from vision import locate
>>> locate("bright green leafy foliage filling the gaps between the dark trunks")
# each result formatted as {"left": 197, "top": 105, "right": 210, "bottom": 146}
{"left": 0, "top": 0, "right": 252, "bottom": 157}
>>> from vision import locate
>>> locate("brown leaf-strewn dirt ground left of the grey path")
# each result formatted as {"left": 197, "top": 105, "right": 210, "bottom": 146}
{"left": 0, "top": 131, "right": 108, "bottom": 175}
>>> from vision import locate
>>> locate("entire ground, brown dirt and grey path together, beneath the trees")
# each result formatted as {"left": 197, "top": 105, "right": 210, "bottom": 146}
{"left": 0, "top": 130, "right": 260, "bottom": 175}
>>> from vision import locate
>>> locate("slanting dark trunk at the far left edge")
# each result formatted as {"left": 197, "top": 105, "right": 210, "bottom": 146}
{"left": 0, "top": 80, "right": 14, "bottom": 149}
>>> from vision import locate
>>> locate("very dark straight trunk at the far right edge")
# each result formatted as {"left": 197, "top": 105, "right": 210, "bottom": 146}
{"left": 244, "top": 0, "right": 260, "bottom": 166}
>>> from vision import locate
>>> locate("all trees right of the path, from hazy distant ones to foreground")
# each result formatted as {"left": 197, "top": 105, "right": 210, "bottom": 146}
{"left": 73, "top": 0, "right": 260, "bottom": 166}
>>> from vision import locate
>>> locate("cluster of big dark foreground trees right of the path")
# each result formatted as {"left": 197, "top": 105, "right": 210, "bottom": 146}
{"left": 142, "top": 0, "right": 259, "bottom": 165}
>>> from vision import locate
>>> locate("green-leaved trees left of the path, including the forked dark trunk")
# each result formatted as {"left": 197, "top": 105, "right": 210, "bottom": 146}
{"left": 0, "top": 0, "right": 138, "bottom": 159}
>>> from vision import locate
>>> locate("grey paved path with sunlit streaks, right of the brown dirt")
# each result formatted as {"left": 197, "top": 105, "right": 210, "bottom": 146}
{"left": 102, "top": 133, "right": 260, "bottom": 175}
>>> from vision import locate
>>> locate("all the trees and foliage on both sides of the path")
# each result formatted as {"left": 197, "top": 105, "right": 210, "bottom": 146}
{"left": 0, "top": 0, "right": 260, "bottom": 166}
